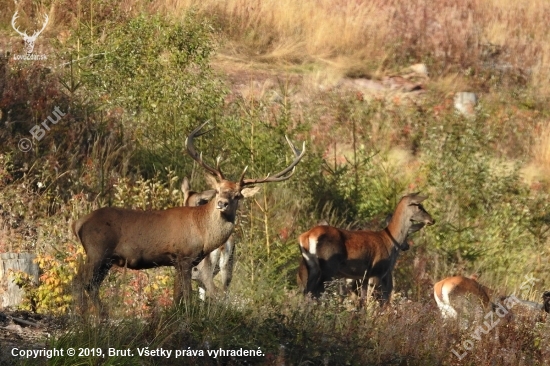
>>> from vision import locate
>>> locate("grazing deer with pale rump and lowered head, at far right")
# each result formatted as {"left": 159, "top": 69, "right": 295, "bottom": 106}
{"left": 434, "top": 276, "right": 550, "bottom": 319}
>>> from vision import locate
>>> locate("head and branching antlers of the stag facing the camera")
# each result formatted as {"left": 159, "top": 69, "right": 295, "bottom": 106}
{"left": 185, "top": 121, "right": 305, "bottom": 216}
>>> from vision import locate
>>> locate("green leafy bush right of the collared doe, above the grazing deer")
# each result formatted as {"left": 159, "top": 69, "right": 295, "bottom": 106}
{"left": 422, "top": 115, "right": 542, "bottom": 284}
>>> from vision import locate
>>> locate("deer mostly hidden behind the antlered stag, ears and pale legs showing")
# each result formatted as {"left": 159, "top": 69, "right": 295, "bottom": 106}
{"left": 181, "top": 178, "right": 235, "bottom": 300}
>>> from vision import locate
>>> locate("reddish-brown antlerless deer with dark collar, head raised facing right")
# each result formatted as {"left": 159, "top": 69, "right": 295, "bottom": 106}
{"left": 299, "top": 193, "right": 435, "bottom": 300}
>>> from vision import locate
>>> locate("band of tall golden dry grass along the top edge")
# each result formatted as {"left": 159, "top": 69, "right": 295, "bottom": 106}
{"left": 140, "top": 0, "right": 550, "bottom": 89}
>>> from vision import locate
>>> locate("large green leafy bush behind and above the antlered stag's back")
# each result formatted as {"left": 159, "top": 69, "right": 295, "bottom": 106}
{"left": 76, "top": 13, "right": 225, "bottom": 177}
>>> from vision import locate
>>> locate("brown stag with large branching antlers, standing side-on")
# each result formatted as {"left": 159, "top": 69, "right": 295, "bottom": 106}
{"left": 72, "top": 122, "right": 305, "bottom": 309}
